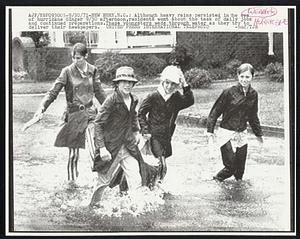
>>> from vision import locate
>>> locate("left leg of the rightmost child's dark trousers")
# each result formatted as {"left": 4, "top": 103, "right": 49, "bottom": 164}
{"left": 216, "top": 141, "right": 235, "bottom": 181}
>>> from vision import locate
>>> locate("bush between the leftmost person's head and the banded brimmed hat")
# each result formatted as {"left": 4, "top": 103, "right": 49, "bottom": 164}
{"left": 95, "top": 51, "right": 133, "bottom": 83}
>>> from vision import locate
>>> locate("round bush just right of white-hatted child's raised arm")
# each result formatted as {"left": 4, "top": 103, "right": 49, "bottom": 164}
{"left": 184, "top": 68, "right": 212, "bottom": 88}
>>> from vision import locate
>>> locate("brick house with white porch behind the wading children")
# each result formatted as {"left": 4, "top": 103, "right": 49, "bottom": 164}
{"left": 12, "top": 31, "right": 283, "bottom": 81}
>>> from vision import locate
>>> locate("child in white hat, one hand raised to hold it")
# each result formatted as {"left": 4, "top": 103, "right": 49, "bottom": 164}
{"left": 138, "top": 66, "right": 194, "bottom": 180}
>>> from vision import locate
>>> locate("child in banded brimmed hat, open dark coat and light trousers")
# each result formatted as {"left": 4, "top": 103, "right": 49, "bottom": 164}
{"left": 90, "top": 66, "right": 155, "bottom": 207}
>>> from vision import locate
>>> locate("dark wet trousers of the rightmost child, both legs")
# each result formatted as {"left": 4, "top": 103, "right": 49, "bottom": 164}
{"left": 216, "top": 141, "right": 248, "bottom": 181}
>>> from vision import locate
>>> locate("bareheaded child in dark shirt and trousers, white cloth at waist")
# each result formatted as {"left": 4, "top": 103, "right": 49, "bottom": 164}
{"left": 207, "top": 63, "right": 263, "bottom": 182}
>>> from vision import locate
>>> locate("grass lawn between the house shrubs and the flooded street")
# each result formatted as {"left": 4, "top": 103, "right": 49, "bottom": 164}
{"left": 12, "top": 78, "right": 284, "bottom": 127}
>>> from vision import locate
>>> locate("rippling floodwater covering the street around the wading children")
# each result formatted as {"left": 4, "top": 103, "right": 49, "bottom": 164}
{"left": 11, "top": 96, "right": 290, "bottom": 232}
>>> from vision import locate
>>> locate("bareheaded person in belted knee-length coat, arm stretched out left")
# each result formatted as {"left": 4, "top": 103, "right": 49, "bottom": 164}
{"left": 34, "top": 43, "right": 106, "bottom": 180}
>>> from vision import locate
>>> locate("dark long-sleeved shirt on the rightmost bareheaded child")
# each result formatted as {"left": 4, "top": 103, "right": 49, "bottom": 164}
{"left": 207, "top": 84, "right": 262, "bottom": 136}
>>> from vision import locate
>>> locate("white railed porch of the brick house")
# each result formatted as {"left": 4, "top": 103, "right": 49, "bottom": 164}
{"left": 48, "top": 31, "right": 176, "bottom": 54}
